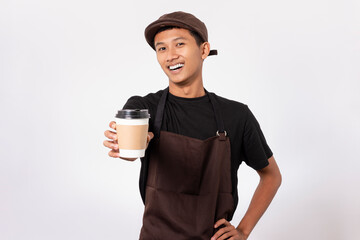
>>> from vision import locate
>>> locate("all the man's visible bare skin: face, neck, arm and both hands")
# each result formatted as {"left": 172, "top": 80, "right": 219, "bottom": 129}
{"left": 103, "top": 28, "right": 281, "bottom": 240}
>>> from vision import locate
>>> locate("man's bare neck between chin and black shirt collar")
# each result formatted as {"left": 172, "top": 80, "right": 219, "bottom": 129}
{"left": 169, "top": 80, "right": 205, "bottom": 98}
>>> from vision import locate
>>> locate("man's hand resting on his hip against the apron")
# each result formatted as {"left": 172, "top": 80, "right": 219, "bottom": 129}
{"left": 211, "top": 218, "right": 247, "bottom": 240}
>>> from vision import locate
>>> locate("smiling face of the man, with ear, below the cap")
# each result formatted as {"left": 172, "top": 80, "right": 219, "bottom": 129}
{"left": 154, "top": 28, "right": 210, "bottom": 86}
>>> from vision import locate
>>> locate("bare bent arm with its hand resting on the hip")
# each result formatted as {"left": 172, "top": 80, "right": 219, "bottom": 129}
{"left": 211, "top": 156, "right": 281, "bottom": 240}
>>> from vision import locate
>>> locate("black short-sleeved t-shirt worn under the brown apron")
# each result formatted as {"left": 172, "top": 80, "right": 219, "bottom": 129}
{"left": 124, "top": 90, "right": 273, "bottom": 215}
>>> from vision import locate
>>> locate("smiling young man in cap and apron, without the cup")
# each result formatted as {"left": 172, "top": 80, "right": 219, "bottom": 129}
{"left": 104, "top": 12, "right": 281, "bottom": 240}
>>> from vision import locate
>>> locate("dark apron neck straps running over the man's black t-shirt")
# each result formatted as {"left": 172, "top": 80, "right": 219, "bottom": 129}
{"left": 154, "top": 87, "right": 226, "bottom": 137}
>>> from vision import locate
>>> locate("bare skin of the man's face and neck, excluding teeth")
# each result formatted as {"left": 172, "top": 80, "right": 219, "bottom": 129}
{"left": 154, "top": 28, "right": 210, "bottom": 98}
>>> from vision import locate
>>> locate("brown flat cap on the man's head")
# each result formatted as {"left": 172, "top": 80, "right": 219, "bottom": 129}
{"left": 145, "top": 11, "right": 217, "bottom": 55}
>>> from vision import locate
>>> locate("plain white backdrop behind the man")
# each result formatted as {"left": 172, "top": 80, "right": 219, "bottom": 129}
{"left": 0, "top": 0, "right": 360, "bottom": 240}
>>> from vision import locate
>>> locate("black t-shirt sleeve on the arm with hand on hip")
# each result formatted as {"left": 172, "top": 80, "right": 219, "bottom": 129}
{"left": 243, "top": 106, "right": 273, "bottom": 170}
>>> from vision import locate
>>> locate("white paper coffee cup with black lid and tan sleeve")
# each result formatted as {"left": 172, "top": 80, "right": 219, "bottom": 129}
{"left": 115, "top": 109, "right": 150, "bottom": 158}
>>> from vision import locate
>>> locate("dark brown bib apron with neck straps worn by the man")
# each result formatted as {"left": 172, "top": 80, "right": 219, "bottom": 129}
{"left": 140, "top": 88, "right": 234, "bottom": 240}
